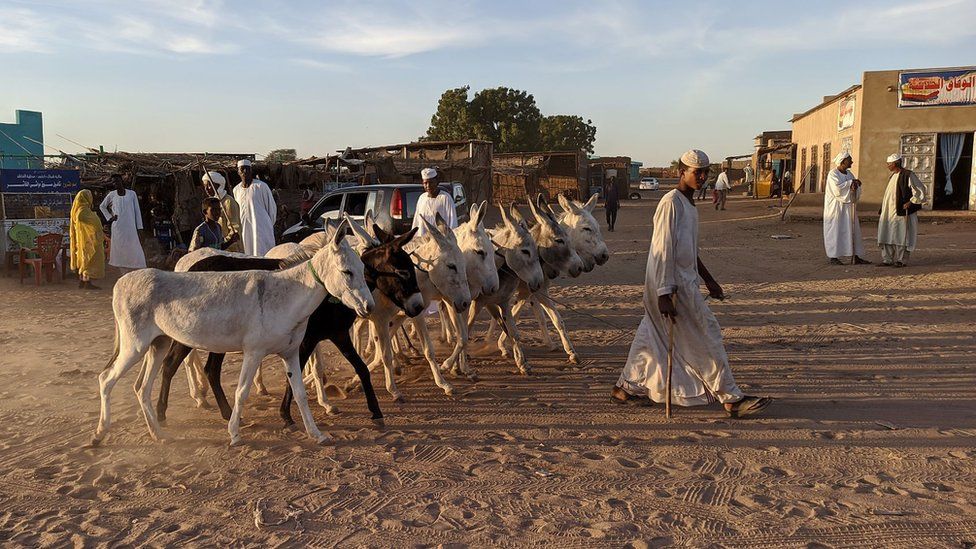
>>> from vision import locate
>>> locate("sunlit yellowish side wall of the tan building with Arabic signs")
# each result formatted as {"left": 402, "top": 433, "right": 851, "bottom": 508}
{"left": 793, "top": 89, "right": 862, "bottom": 192}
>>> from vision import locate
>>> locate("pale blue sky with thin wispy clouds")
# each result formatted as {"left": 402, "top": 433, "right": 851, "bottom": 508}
{"left": 0, "top": 0, "right": 976, "bottom": 166}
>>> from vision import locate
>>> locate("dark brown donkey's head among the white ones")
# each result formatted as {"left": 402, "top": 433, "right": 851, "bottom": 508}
{"left": 362, "top": 225, "right": 424, "bottom": 317}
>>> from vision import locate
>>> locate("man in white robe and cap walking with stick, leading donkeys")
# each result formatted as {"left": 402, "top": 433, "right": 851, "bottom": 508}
{"left": 610, "top": 150, "right": 772, "bottom": 417}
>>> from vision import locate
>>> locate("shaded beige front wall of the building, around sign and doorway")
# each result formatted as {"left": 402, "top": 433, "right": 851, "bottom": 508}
{"left": 854, "top": 71, "right": 976, "bottom": 207}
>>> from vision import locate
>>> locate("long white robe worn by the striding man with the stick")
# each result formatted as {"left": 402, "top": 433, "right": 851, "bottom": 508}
{"left": 617, "top": 190, "right": 744, "bottom": 406}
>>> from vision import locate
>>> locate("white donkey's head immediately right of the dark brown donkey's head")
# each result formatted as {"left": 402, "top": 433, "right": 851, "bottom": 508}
{"left": 414, "top": 215, "right": 471, "bottom": 312}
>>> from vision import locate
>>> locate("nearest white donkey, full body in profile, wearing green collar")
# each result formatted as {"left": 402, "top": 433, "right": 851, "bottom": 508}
{"left": 92, "top": 218, "right": 374, "bottom": 445}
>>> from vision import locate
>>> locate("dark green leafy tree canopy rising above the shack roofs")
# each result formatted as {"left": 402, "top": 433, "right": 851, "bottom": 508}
{"left": 424, "top": 86, "right": 596, "bottom": 153}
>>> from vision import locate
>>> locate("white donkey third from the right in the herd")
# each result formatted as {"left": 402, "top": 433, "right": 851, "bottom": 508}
{"left": 467, "top": 206, "right": 545, "bottom": 374}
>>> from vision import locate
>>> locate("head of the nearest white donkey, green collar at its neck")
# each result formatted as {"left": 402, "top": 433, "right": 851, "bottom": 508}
{"left": 312, "top": 216, "right": 374, "bottom": 317}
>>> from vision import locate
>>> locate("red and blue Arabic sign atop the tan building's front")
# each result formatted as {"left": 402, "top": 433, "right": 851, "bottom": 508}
{"left": 898, "top": 67, "right": 976, "bottom": 107}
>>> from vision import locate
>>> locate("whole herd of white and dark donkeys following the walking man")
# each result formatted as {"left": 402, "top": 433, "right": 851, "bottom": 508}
{"left": 92, "top": 195, "right": 609, "bottom": 445}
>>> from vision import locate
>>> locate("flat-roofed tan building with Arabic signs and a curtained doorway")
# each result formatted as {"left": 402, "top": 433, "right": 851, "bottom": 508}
{"left": 792, "top": 67, "right": 976, "bottom": 210}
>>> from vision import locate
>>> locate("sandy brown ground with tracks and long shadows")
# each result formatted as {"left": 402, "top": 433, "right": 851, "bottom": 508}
{"left": 0, "top": 191, "right": 976, "bottom": 547}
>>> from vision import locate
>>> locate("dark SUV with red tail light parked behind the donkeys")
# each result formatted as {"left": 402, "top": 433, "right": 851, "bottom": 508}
{"left": 281, "top": 181, "right": 468, "bottom": 242}
